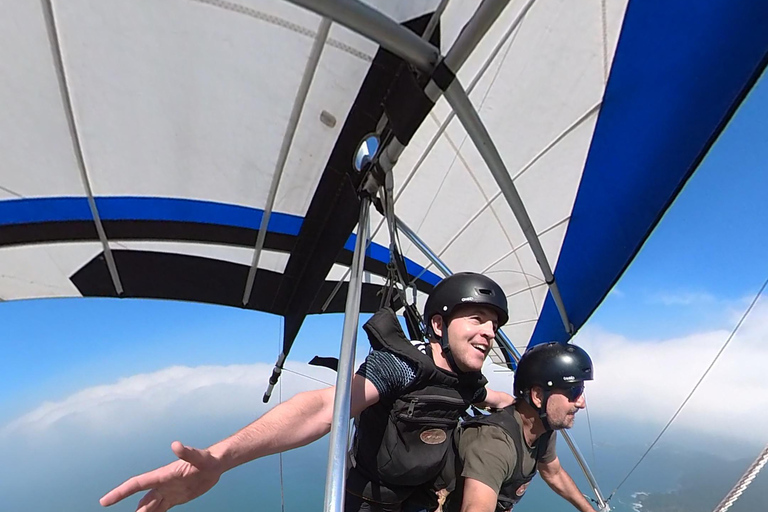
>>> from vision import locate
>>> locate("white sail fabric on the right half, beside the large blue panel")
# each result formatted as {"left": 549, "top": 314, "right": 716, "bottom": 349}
{"left": 368, "top": 2, "right": 626, "bottom": 361}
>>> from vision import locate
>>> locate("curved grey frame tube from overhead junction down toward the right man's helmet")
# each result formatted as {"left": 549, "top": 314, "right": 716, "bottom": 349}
{"left": 445, "top": 80, "right": 574, "bottom": 335}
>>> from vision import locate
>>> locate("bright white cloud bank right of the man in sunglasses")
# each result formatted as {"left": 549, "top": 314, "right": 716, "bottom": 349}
{"left": 575, "top": 304, "right": 768, "bottom": 442}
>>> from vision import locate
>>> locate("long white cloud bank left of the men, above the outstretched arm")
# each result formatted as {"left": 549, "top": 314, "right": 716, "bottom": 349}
{"left": 0, "top": 364, "right": 335, "bottom": 438}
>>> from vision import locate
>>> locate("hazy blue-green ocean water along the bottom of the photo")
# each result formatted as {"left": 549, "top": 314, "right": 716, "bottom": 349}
{"left": 0, "top": 420, "right": 768, "bottom": 512}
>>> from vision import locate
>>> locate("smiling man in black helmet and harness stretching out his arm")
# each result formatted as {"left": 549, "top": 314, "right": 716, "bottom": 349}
{"left": 100, "top": 272, "right": 513, "bottom": 512}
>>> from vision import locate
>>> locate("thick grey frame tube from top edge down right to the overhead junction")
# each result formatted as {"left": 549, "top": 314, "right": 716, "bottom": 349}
{"left": 288, "top": 0, "right": 440, "bottom": 72}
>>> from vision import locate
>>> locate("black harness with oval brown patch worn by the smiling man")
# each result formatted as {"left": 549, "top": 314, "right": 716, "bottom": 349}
{"left": 351, "top": 308, "right": 488, "bottom": 487}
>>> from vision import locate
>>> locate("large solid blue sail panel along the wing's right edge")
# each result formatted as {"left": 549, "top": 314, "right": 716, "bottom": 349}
{"left": 530, "top": 0, "right": 768, "bottom": 345}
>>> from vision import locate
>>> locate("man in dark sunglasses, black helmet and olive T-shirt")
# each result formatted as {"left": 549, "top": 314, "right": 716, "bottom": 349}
{"left": 447, "top": 343, "right": 594, "bottom": 512}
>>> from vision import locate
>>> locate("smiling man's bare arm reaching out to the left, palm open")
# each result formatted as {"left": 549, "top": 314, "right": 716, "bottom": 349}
{"left": 99, "top": 375, "right": 379, "bottom": 512}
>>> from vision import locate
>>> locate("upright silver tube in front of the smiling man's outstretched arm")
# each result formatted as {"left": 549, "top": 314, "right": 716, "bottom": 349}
{"left": 324, "top": 197, "right": 371, "bottom": 512}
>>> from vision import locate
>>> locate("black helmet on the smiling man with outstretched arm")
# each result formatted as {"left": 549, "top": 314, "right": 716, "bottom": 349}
{"left": 424, "top": 272, "right": 509, "bottom": 338}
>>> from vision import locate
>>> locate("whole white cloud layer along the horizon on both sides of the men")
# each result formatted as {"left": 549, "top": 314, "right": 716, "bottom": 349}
{"left": 6, "top": 304, "right": 768, "bottom": 442}
